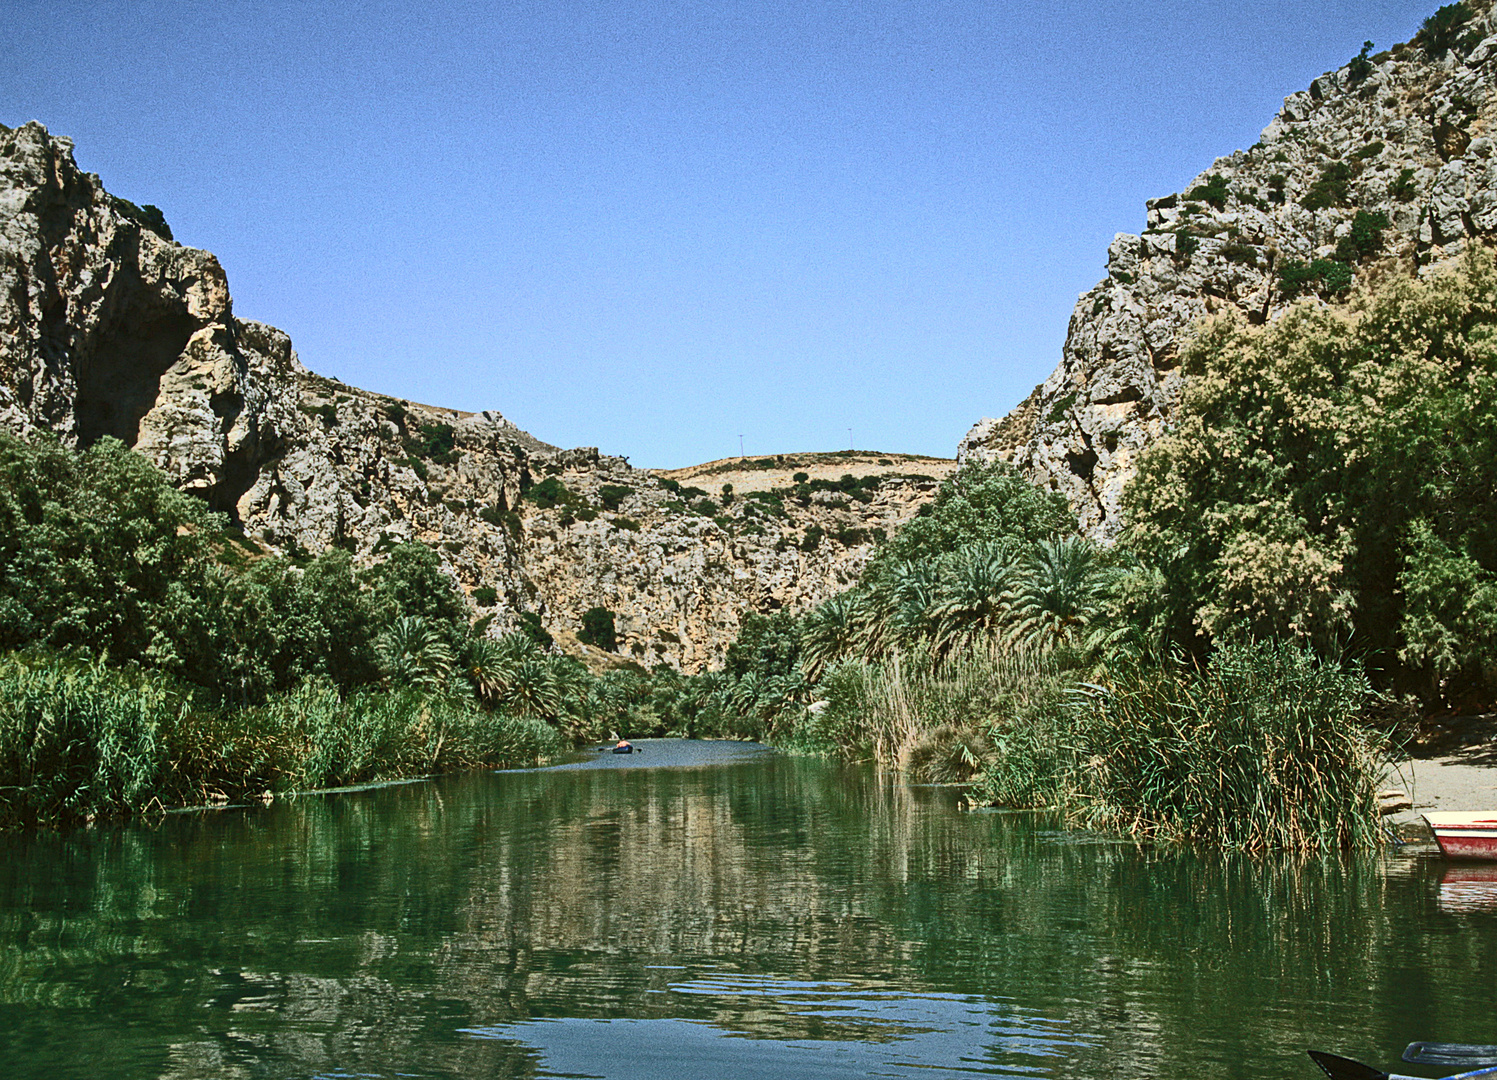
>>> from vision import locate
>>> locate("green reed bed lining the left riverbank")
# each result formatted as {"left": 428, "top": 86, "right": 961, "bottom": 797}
{"left": 0, "top": 653, "right": 561, "bottom": 827}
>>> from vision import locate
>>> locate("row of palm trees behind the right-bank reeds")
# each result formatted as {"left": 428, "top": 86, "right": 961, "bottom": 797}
{"left": 801, "top": 536, "right": 1118, "bottom": 682}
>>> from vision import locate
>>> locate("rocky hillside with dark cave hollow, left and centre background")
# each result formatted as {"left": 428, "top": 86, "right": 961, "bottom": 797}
{"left": 0, "top": 123, "right": 952, "bottom": 671}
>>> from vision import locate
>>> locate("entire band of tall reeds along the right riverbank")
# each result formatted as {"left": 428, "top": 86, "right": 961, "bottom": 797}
{"left": 790, "top": 643, "right": 1389, "bottom": 851}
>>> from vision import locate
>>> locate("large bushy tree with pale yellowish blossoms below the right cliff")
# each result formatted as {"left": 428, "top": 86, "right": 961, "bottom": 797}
{"left": 1124, "top": 252, "right": 1497, "bottom": 706}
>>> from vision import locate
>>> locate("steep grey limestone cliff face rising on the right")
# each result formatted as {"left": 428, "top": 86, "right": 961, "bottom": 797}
{"left": 958, "top": 1, "right": 1497, "bottom": 539}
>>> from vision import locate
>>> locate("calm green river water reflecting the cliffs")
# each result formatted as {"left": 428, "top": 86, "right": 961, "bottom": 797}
{"left": 0, "top": 741, "right": 1497, "bottom": 1080}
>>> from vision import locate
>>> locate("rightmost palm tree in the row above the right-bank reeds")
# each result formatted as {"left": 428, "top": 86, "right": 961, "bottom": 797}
{"left": 1007, "top": 536, "right": 1115, "bottom": 649}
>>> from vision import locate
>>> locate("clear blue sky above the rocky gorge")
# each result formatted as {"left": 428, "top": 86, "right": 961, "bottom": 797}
{"left": 0, "top": 0, "right": 1439, "bottom": 467}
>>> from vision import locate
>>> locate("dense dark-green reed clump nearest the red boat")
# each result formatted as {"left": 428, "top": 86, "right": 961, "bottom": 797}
{"left": 1063, "top": 644, "right": 1386, "bottom": 851}
